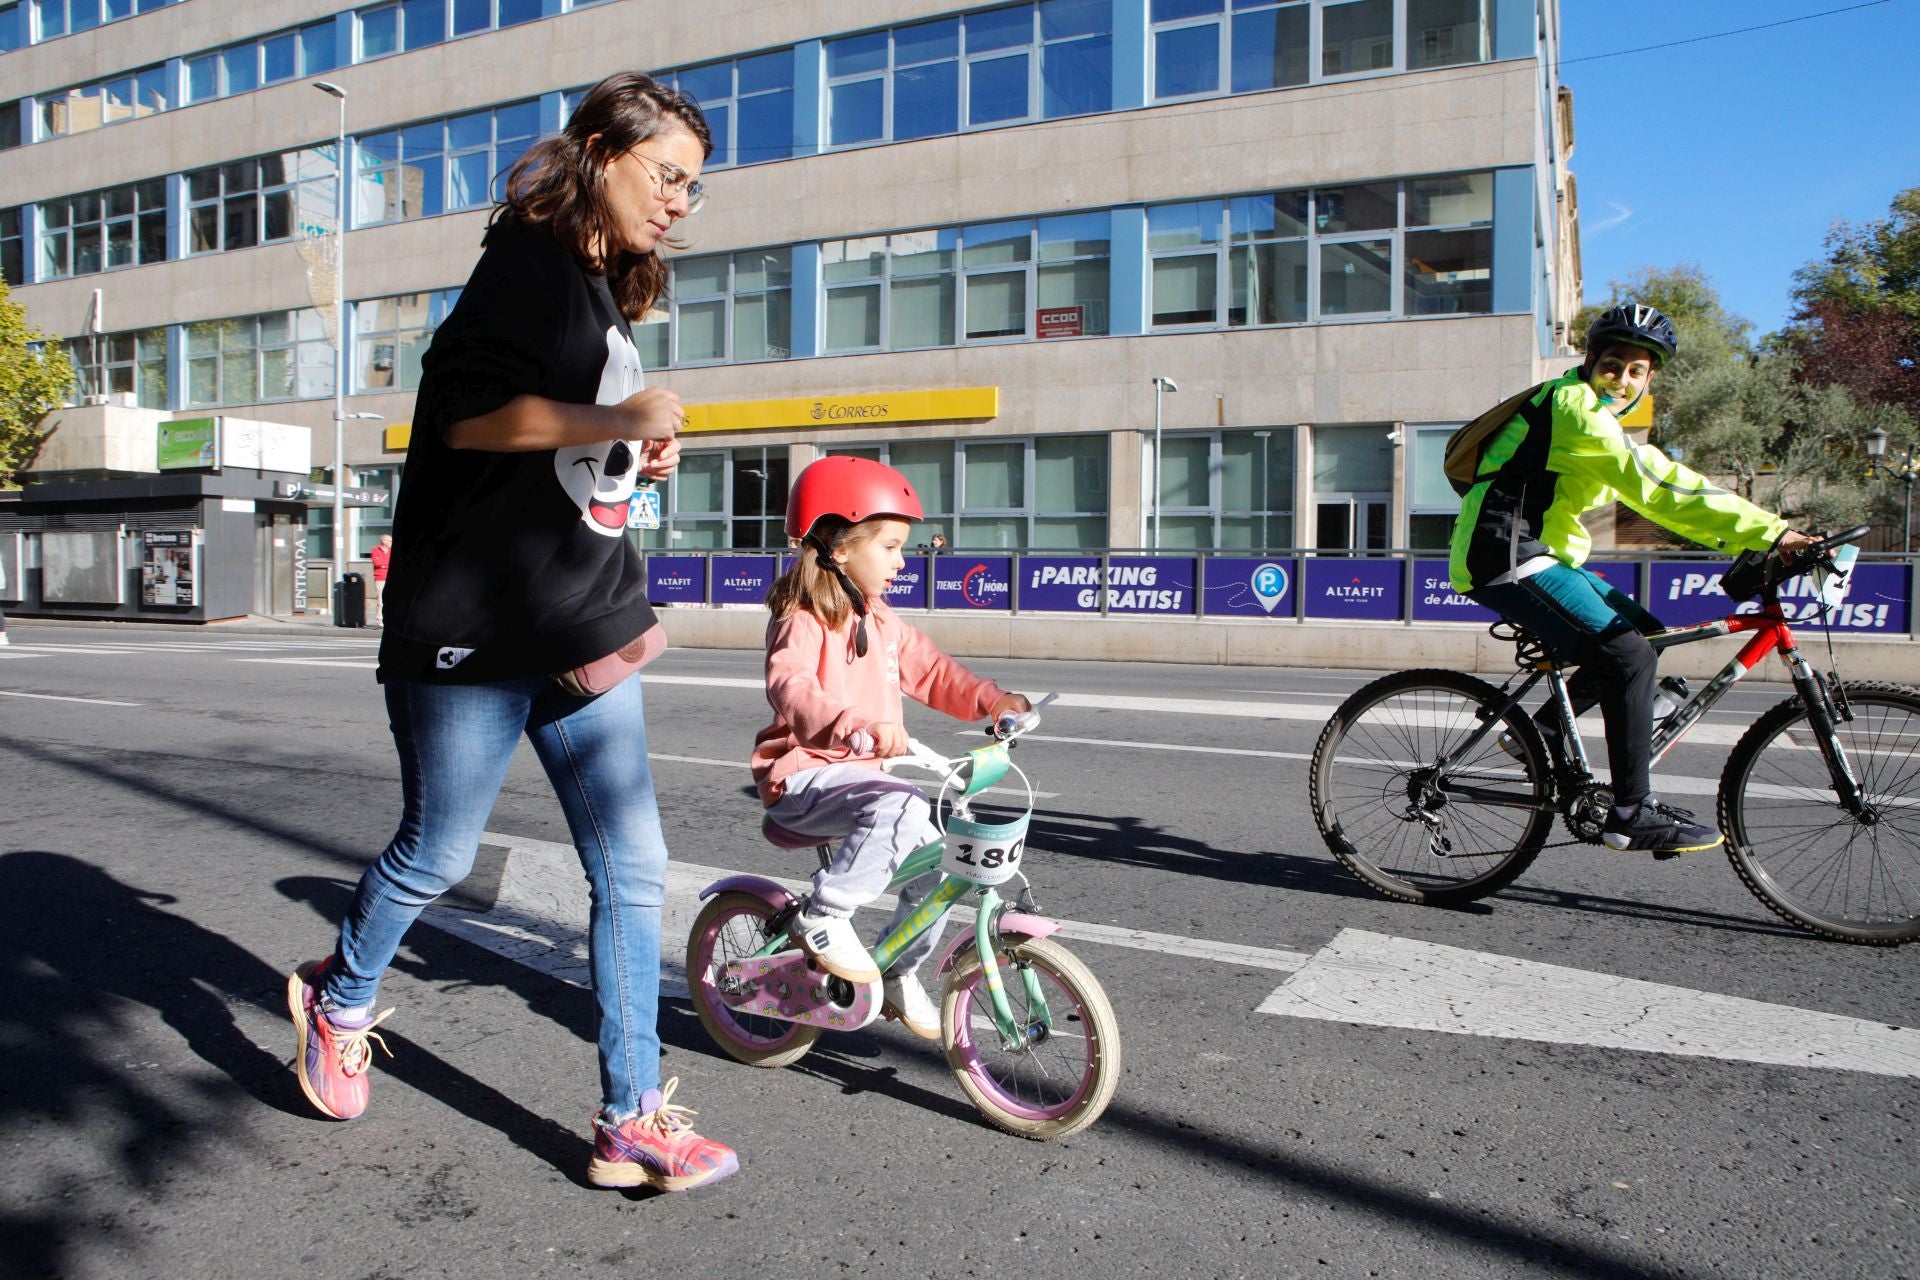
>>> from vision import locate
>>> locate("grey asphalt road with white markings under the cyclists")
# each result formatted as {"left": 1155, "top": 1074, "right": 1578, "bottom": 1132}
{"left": 0, "top": 620, "right": 1920, "bottom": 1280}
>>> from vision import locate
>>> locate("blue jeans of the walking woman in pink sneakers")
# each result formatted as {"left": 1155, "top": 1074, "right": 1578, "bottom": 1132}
{"left": 324, "top": 676, "right": 666, "bottom": 1121}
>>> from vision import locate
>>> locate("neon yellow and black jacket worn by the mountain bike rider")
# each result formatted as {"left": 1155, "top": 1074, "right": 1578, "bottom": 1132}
{"left": 1448, "top": 368, "right": 1788, "bottom": 591}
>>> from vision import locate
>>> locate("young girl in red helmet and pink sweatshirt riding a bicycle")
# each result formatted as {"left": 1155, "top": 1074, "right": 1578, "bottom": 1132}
{"left": 753, "top": 457, "right": 1033, "bottom": 1040}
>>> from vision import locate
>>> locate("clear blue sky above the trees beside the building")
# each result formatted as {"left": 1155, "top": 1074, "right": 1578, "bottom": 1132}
{"left": 1561, "top": 0, "right": 1920, "bottom": 336}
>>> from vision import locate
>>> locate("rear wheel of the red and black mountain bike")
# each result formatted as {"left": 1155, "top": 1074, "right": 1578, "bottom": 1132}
{"left": 1309, "top": 670, "right": 1553, "bottom": 906}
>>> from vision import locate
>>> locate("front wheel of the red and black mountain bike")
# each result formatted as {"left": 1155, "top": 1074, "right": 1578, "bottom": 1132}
{"left": 1720, "top": 683, "right": 1920, "bottom": 946}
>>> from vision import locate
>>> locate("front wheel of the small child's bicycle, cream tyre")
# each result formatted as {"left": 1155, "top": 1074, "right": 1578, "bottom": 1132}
{"left": 941, "top": 938, "right": 1119, "bottom": 1142}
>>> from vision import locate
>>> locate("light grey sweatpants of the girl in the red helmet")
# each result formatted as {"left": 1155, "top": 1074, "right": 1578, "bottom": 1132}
{"left": 766, "top": 764, "right": 947, "bottom": 973}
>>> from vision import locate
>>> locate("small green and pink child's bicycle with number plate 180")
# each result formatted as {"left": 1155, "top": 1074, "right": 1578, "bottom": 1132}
{"left": 687, "top": 699, "right": 1119, "bottom": 1138}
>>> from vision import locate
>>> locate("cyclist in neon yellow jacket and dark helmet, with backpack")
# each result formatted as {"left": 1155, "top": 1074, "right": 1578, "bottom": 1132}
{"left": 1448, "top": 303, "right": 1812, "bottom": 854}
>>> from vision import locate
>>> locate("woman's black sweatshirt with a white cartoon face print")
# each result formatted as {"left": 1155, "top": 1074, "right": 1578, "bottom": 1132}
{"left": 378, "top": 217, "right": 657, "bottom": 683}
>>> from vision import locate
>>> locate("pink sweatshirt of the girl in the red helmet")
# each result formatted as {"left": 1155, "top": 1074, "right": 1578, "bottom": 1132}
{"left": 753, "top": 599, "right": 1006, "bottom": 804}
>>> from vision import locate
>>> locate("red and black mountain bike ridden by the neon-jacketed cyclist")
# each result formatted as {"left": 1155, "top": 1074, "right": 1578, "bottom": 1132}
{"left": 1311, "top": 526, "right": 1920, "bottom": 946}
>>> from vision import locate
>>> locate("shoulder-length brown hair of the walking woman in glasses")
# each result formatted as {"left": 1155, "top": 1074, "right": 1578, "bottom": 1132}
{"left": 488, "top": 71, "right": 714, "bottom": 320}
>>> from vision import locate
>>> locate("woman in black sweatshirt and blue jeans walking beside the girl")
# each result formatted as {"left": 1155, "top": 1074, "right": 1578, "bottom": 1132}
{"left": 288, "top": 73, "right": 739, "bottom": 1190}
